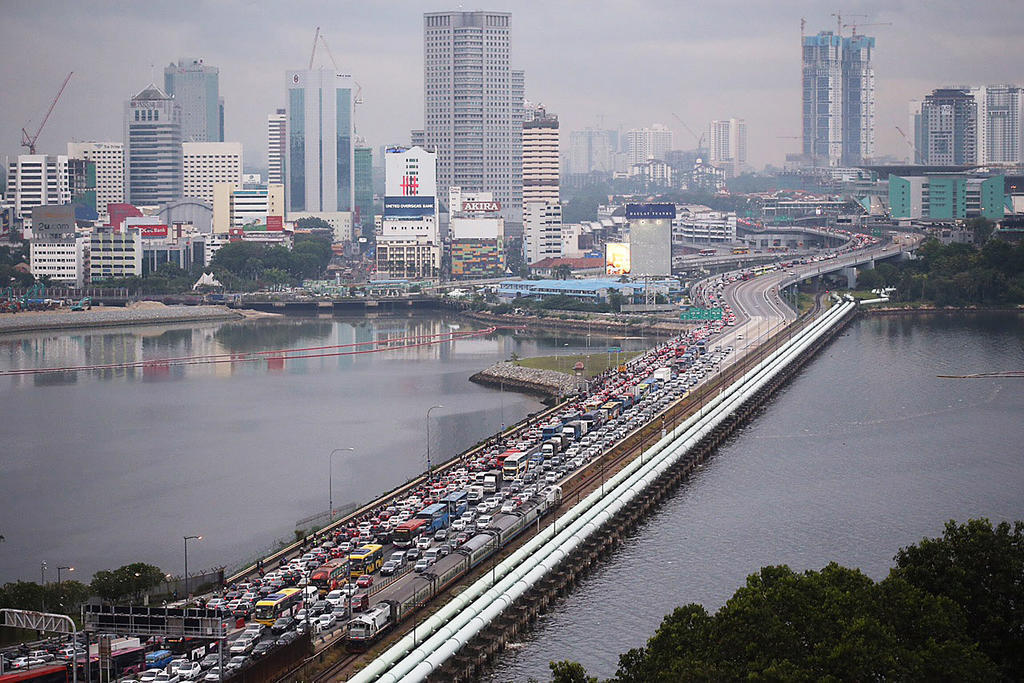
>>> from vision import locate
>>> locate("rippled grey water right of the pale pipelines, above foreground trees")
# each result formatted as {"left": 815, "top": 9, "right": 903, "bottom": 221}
{"left": 488, "top": 314, "right": 1024, "bottom": 681}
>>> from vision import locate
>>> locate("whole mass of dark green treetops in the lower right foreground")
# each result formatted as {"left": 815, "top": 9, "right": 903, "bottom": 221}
{"left": 551, "top": 519, "right": 1024, "bottom": 683}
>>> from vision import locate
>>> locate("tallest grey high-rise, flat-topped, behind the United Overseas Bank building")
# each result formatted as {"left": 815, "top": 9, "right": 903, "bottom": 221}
{"left": 423, "top": 11, "right": 523, "bottom": 222}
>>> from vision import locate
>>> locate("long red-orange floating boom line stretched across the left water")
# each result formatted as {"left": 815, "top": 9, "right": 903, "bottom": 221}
{"left": 0, "top": 327, "right": 498, "bottom": 377}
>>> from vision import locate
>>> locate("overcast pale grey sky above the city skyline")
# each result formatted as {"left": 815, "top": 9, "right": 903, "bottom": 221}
{"left": 0, "top": 0, "right": 1024, "bottom": 174}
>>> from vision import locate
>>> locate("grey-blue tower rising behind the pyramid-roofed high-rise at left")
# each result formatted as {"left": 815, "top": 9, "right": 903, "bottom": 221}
{"left": 164, "top": 57, "right": 224, "bottom": 142}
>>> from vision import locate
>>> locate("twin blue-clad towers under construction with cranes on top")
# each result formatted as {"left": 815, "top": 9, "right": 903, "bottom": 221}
{"left": 802, "top": 31, "right": 874, "bottom": 166}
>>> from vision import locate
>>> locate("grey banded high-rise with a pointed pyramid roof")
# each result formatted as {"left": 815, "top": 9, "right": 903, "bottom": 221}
{"left": 125, "top": 84, "right": 182, "bottom": 206}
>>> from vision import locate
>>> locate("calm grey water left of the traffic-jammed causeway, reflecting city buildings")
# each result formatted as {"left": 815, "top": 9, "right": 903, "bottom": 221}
{"left": 0, "top": 315, "right": 642, "bottom": 583}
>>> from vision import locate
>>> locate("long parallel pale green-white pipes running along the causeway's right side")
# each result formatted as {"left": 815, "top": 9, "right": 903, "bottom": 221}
{"left": 353, "top": 304, "right": 854, "bottom": 681}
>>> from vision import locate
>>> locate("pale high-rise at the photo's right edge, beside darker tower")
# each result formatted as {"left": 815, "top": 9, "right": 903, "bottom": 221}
{"left": 971, "top": 85, "right": 1024, "bottom": 164}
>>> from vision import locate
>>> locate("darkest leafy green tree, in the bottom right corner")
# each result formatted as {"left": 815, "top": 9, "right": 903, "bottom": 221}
{"left": 892, "top": 519, "right": 1024, "bottom": 680}
